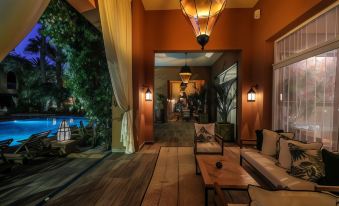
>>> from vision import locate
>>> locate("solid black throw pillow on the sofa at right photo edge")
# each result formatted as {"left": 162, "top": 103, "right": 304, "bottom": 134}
{"left": 321, "top": 149, "right": 339, "bottom": 186}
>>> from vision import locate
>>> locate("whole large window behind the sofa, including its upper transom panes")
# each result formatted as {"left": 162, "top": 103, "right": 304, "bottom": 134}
{"left": 273, "top": 3, "right": 339, "bottom": 151}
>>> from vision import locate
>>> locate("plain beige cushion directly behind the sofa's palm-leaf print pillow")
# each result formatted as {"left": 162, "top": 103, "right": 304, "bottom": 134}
{"left": 279, "top": 138, "right": 322, "bottom": 170}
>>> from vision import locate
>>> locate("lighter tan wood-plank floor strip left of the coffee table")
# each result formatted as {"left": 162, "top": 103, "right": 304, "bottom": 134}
{"left": 142, "top": 147, "right": 204, "bottom": 206}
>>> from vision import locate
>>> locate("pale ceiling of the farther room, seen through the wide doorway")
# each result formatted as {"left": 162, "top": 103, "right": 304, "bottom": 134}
{"left": 154, "top": 52, "right": 223, "bottom": 67}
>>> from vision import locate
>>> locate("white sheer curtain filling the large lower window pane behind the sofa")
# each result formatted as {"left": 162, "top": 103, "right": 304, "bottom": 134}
{"left": 273, "top": 49, "right": 339, "bottom": 151}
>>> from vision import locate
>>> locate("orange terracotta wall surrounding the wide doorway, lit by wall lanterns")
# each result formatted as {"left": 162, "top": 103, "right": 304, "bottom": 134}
{"left": 133, "top": 0, "right": 335, "bottom": 147}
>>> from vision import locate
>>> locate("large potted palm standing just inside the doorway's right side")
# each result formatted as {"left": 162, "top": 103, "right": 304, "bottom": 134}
{"left": 214, "top": 78, "right": 237, "bottom": 142}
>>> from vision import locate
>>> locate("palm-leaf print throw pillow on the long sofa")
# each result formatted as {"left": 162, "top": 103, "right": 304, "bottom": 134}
{"left": 288, "top": 143, "right": 325, "bottom": 182}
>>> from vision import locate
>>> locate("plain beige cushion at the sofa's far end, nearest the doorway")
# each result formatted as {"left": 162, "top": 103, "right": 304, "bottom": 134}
{"left": 261, "top": 129, "right": 280, "bottom": 156}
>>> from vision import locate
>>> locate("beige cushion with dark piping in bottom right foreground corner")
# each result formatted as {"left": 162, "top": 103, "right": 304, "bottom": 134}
{"left": 248, "top": 185, "right": 337, "bottom": 206}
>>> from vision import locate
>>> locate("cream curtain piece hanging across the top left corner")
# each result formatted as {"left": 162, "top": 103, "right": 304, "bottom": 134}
{"left": 0, "top": 0, "right": 50, "bottom": 61}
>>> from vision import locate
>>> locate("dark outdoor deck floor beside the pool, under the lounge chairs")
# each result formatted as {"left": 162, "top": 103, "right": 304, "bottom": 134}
{"left": 0, "top": 147, "right": 109, "bottom": 206}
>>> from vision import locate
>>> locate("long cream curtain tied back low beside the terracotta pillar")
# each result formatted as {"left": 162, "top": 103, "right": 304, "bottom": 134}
{"left": 98, "top": 0, "right": 135, "bottom": 154}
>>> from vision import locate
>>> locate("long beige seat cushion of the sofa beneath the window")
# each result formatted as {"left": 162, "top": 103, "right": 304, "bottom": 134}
{"left": 241, "top": 149, "right": 315, "bottom": 190}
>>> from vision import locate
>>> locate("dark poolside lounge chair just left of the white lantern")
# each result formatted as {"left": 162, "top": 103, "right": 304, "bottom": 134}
{"left": 3, "top": 131, "right": 51, "bottom": 164}
